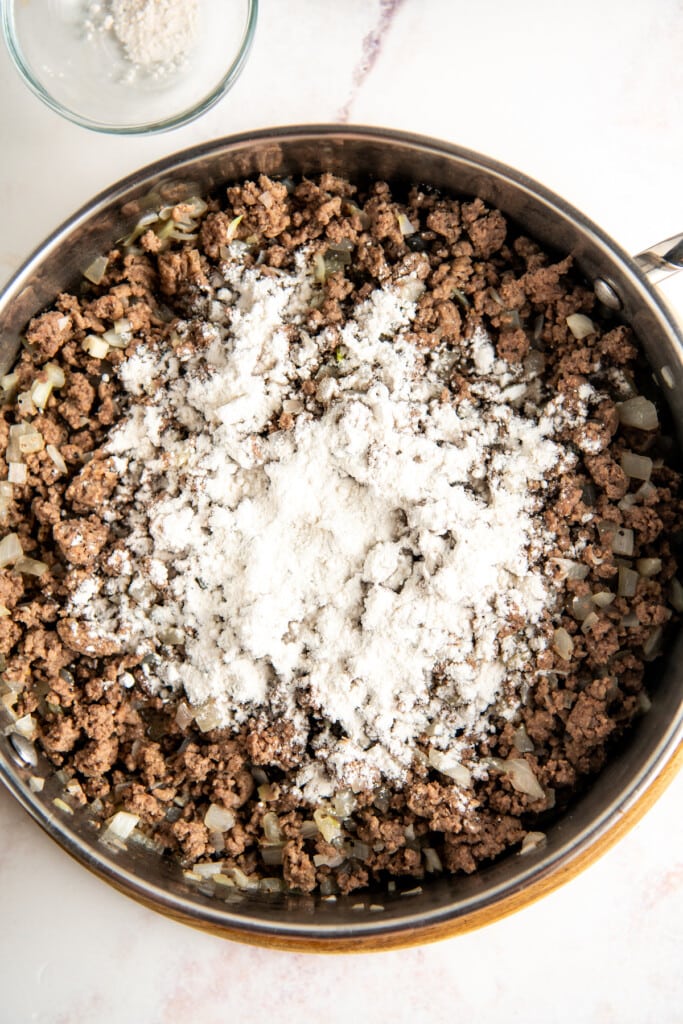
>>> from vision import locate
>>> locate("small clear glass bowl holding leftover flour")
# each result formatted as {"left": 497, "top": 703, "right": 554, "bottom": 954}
{"left": 0, "top": 0, "right": 258, "bottom": 135}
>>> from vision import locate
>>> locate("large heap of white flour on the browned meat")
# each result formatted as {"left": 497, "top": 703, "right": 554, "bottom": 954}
{"left": 72, "top": 254, "right": 581, "bottom": 800}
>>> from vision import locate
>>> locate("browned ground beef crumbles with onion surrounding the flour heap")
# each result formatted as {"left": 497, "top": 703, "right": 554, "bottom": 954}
{"left": 0, "top": 174, "right": 680, "bottom": 894}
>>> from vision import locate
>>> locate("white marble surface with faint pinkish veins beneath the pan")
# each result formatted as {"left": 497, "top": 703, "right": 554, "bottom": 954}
{"left": 0, "top": 0, "right": 683, "bottom": 1024}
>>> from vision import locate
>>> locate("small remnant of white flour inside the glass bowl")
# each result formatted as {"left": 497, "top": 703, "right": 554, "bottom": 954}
{"left": 85, "top": 0, "right": 199, "bottom": 77}
